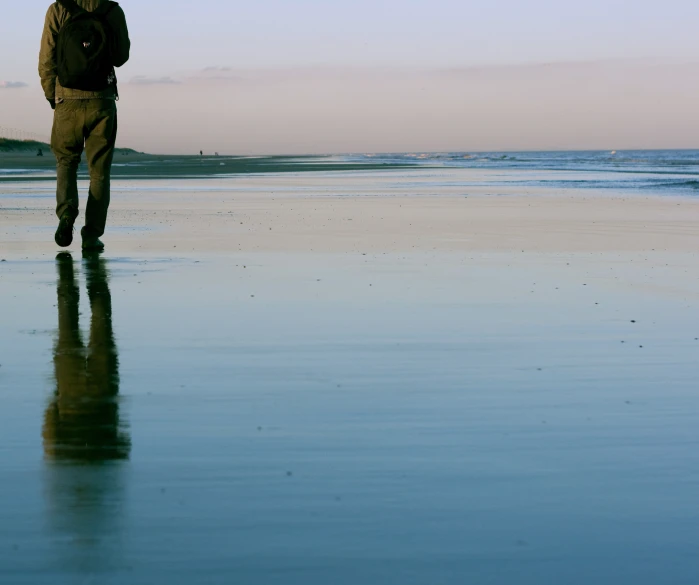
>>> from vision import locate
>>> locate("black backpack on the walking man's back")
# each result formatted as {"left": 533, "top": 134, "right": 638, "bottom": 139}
{"left": 56, "top": 0, "right": 117, "bottom": 91}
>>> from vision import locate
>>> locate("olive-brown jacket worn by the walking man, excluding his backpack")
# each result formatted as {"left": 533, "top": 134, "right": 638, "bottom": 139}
{"left": 39, "top": 0, "right": 131, "bottom": 101}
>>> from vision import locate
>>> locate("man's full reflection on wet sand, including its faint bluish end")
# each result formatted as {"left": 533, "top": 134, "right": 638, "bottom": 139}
{"left": 43, "top": 253, "right": 131, "bottom": 574}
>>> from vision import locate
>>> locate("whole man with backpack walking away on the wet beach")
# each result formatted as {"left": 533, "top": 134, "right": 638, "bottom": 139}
{"left": 39, "top": 0, "right": 131, "bottom": 250}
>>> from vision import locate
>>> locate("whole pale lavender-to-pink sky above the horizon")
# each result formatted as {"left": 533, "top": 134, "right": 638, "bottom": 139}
{"left": 0, "top": 0, "right": 699, "bottom": 154}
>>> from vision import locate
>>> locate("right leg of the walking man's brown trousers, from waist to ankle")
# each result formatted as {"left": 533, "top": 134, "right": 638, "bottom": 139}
{"left": 83, "top": 100, "right": 117, "bottom": 238}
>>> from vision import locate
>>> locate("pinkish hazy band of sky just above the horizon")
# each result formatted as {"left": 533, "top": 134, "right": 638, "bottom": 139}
{"left": 0, "top": 60, "right": 699, "bottom": 154}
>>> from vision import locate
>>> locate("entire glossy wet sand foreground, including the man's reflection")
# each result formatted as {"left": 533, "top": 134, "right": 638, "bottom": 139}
{"left": 0, "top": 170, "right": 699, "bottom": 585}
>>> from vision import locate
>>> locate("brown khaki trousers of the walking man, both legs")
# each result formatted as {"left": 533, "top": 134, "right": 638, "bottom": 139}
{"left": 51, "top": 99, "right": 117, "bottom": 237}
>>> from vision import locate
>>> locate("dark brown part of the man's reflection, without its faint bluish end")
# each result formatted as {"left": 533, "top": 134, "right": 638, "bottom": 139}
{"left": 43, "top": 253, "right": 130, "bottom": 463}
